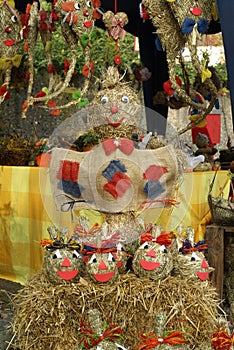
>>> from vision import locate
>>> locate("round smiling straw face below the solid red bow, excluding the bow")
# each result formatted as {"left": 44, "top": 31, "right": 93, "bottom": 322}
{"left": 133, "top": 242, "right": 173, "bottom": 280}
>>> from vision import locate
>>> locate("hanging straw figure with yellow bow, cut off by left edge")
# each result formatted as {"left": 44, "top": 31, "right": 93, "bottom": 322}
{"left": 0, "top": 0, "right": 23, "bottom": 103}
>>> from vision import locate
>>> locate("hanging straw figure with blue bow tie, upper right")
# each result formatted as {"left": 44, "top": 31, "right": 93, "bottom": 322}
{"left": 143, "top": 0, "right": 217, "bottom": 133}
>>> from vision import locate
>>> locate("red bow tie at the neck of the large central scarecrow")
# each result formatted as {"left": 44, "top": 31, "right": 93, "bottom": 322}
{"left": 102, "top": 138, "right": 134, "bottom": 156}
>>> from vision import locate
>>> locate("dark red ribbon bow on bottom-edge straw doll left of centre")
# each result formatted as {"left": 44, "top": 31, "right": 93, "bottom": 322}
{"left": 80, "top": 320, "right": 122, "bottom": 349}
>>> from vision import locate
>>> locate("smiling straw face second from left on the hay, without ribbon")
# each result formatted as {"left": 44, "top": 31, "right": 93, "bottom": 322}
{"left": 86, "top": 253, "right": 118, "bottom": 283}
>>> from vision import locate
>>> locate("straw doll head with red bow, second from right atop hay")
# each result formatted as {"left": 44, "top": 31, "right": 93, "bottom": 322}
{"left": 133, "top": 229, "right": 173, "bottom": 281}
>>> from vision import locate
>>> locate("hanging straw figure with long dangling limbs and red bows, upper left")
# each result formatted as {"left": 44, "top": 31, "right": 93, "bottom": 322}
{"left": 22, "top": 0, "right": 100, "bottom": 118}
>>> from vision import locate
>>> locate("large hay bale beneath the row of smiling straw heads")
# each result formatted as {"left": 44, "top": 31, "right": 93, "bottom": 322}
{"left": 13, "top": 272, "right": 219, "bottom": 350}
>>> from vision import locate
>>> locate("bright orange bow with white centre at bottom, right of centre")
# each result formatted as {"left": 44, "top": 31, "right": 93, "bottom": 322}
{"left": 138, "top": 332, "right": 187, "bottom": 350}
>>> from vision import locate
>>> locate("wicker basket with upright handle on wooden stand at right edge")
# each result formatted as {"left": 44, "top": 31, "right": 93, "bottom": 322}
{"left": 208, "top": 171, "right": 234, "bottom": 226}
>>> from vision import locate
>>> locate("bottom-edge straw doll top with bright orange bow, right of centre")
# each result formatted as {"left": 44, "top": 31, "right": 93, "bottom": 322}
{"left": 137, "top": 311, "right": 189, "bottom": 350}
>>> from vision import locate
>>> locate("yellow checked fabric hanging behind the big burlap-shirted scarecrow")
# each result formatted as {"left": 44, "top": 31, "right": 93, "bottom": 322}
{"left": 0, "top": 166, "right": 229, "bottom": 284}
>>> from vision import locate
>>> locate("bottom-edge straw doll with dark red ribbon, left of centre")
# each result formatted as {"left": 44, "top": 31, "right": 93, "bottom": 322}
{"left": 76, "top": 309, "right": 125, "bottom": 350}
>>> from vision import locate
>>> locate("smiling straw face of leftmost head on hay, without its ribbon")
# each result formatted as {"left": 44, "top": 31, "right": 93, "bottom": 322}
{"left": 43, "top": 248, "right": 84, "bottom": 284}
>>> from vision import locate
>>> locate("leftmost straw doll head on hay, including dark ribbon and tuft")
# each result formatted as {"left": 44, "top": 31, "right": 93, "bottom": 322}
{"left": 42, "top": 227, "right": 84, "bottom": 285}
